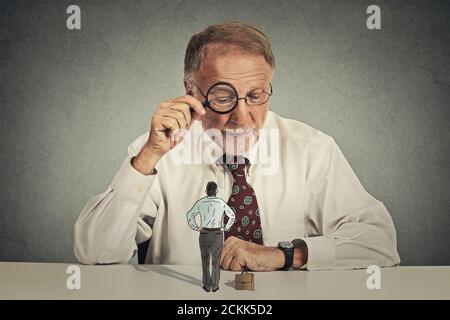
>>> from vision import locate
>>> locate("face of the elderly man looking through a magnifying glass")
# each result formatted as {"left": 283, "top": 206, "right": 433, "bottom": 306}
{"left": 186, "top": 50, "right": 273, "bottom": 154}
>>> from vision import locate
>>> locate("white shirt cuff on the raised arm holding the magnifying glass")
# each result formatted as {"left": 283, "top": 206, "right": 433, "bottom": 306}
{"left": 111, "top": 156, "right": 157, "bottom": 202}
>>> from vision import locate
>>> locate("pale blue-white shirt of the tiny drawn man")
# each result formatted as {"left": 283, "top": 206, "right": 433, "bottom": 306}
{"left": 186, "top": 196, "right": 236, "bottom": 231}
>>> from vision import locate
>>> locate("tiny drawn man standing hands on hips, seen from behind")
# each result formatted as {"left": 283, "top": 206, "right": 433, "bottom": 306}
{"left": 186, "top": 181, "right": 236, "bottom": 292}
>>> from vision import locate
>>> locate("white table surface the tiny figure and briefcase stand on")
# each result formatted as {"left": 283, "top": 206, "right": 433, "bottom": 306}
{"left": 0, "top": 262, "right": 450, "bottom": 300}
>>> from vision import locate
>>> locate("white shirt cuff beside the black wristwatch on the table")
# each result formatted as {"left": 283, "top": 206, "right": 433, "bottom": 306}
{"left": 303, "top": 236, "right": 335, "bottom": 270}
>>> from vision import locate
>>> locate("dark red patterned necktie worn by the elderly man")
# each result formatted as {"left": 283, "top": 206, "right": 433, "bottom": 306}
{"left": 224, "top": 156, "right": 263, "bottom": 244}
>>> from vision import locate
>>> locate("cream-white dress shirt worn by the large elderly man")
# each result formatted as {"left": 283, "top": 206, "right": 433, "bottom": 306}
{"left": 75, "top": 111, "right": 400, "bottom": 270}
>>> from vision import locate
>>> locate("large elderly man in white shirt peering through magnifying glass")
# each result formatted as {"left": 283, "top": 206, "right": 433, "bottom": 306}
{"left": 75, "top": 22, "right": 400, "bottom": 271}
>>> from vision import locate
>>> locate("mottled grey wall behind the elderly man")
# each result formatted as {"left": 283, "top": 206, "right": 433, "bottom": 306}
{"left": 0, "top": 0, "right": 450, "bottom": 265}
